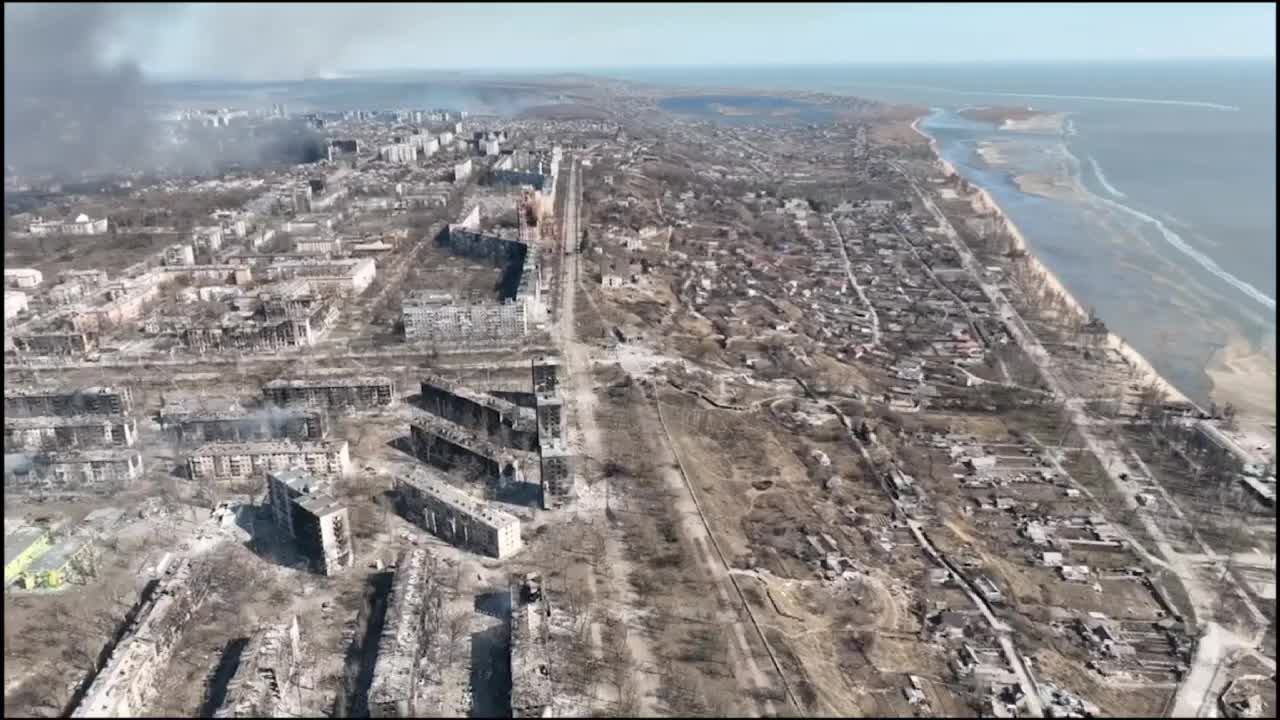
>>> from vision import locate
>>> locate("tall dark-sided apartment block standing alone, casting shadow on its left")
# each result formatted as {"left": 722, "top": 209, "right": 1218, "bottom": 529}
{"left": 266, "top": 470, "right": 353, "bottom": 575}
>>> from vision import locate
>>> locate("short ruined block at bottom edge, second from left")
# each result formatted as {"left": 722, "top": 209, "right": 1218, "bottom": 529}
{"left": 214, "top": 615, "right": 302, "bottom": 717}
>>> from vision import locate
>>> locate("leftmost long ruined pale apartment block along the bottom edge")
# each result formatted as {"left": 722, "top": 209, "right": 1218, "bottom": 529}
{"left": 72, "top": 557, "right": 211, "bottom": 717}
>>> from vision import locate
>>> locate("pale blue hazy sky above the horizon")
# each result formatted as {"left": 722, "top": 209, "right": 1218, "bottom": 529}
{"left": 49, "top": 3, "right": 1276, "bottom": 79}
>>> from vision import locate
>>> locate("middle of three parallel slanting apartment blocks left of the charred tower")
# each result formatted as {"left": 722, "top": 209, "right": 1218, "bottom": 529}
{"left": 410, "top": 416, "right": 532, "bottom": 488}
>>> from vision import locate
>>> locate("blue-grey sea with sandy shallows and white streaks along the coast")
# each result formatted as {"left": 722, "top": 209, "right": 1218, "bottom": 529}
{"left": 594, "top": 60, "right": 1276, "bottom": 424}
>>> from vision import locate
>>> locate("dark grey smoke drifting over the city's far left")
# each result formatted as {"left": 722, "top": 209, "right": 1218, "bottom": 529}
{"left": 4, "top": 3, "right": 323, "bottom": 178}
